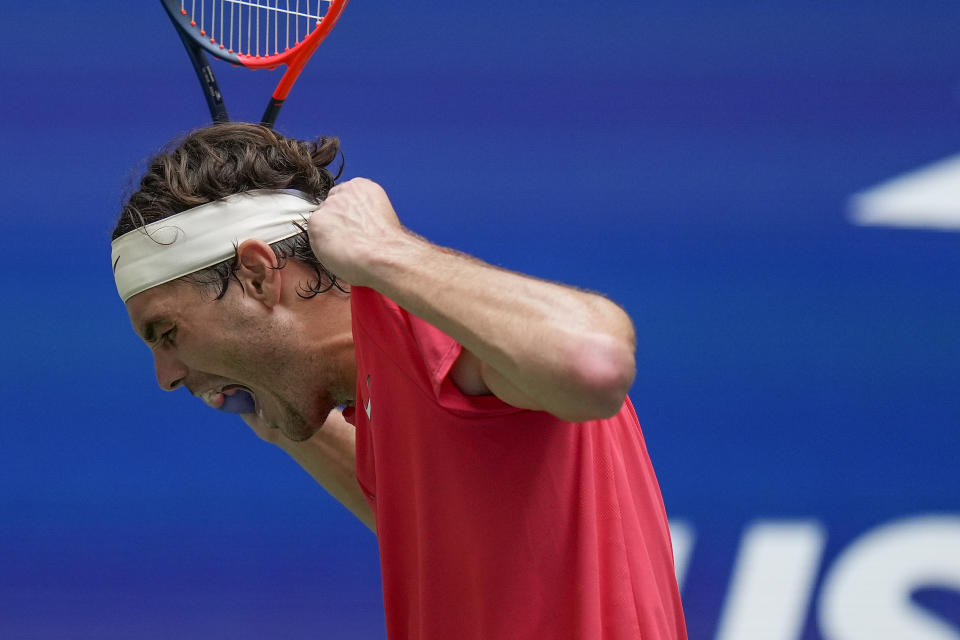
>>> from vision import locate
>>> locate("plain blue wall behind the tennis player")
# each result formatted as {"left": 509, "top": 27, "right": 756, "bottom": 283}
{"left": 0, "top": 0, "right": 960, "bottom": 640}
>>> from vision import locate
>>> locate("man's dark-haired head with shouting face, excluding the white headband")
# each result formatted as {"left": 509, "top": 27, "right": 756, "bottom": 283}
{"left": 113, "top": 124, "right": 353, "bottom": 440}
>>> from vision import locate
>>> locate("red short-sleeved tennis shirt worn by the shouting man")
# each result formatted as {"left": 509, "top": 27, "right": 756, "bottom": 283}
{"left": 346, "top": 287, "right": 687, "bottom": 640}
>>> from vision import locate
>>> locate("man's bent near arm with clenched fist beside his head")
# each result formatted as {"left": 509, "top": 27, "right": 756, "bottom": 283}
{"left": 309, "top": 179, "right": 635, "bottom": 422}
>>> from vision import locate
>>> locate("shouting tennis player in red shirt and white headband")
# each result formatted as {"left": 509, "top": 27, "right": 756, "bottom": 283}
{"left": 112, "top": 124, "right": 686, "bottom": 640}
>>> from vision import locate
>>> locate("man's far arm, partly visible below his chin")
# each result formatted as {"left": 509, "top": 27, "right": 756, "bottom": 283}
{"left": 243, "top": 411, "right": 377, "bottom": 533}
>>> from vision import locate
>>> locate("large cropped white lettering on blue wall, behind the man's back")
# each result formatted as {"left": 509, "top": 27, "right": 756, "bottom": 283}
{"left": 670, "top": 514, "right": 960, "bottom": 640}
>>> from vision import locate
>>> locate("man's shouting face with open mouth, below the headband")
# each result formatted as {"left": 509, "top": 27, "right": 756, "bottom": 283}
{"left": 127, "top": 276, "right": 355, "bottom": 441}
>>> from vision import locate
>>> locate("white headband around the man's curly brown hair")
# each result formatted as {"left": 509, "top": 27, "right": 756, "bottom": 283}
{"left": 110, "top": 189, "right": 317, "bottom": 302}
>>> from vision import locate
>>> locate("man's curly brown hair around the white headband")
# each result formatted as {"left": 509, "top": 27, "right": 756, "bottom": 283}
{"left": 112, "top": 122, "right": 344, "bottom": 299}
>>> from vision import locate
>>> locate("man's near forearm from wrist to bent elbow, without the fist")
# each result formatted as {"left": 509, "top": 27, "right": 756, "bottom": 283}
{"left": 364, "top": 238, "right": 635, "bottom": 421}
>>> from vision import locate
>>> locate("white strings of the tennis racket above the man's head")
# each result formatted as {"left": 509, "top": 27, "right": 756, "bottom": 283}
{"left": 180, "top": 0, "right": 332, "bottom": 57}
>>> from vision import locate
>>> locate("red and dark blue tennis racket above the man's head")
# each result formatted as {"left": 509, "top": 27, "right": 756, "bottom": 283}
{"left": 160, "top": 0, "right": 347, "bottom": 127}
